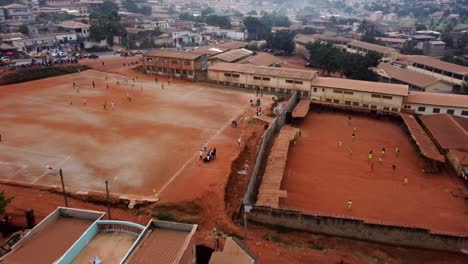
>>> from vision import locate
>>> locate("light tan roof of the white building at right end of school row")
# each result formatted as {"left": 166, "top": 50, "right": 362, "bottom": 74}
{"left": 403, "top": 92, "right": 468, "bottom": 108}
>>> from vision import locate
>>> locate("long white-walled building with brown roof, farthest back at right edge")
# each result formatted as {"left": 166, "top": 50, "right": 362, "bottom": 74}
{"left": 398, "top": 55, "right": 468, "bottom": 86}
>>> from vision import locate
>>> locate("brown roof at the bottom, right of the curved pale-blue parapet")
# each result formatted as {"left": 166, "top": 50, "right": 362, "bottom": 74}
{"left": 125, "top": 220, "right": 197, "bottom": 264}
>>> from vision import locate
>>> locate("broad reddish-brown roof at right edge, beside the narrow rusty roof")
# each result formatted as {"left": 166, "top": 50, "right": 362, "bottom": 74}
{"left": 419, "top": 114, "right": 468, "bottom": 150}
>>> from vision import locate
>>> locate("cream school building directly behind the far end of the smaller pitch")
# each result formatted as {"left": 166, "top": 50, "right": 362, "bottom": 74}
{"left": 311, "top": 77, "right": 408, "bottom": 113}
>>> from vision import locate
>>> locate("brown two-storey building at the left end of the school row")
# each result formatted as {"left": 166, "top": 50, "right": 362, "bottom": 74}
{"left": 143, "top": 50, "right": 207, "bottom": 80}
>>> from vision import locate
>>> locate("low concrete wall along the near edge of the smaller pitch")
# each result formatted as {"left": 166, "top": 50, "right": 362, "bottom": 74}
{"left": 247, "top": 206, "right": 468, "bottom": 253}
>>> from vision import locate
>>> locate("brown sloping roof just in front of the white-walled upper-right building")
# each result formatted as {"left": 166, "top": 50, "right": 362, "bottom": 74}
{"left": 377, "top": 62, "right": 439, "bottom": 88}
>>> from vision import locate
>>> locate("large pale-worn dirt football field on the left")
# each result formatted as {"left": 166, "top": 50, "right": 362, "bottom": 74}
{"left": 0, "top": 64, "right": 256, "bottom": 196}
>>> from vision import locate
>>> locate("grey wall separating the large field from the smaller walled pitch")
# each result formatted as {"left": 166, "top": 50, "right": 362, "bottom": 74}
{"left": 243, "top": 92, "right": 299, "bottom": 205}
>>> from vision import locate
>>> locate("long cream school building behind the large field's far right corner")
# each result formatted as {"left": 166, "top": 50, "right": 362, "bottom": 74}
{"left": 208, "top": 62, "right": 317, "bottom": 98}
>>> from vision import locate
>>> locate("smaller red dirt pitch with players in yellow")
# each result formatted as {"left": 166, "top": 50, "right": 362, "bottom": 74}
{"left": 280, "top": 110, "right": 468, "bottom": 235}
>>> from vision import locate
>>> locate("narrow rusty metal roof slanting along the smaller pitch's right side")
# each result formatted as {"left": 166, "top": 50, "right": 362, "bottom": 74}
{"left": 400, "top": 113, "right": 445, "bottom": 163}
